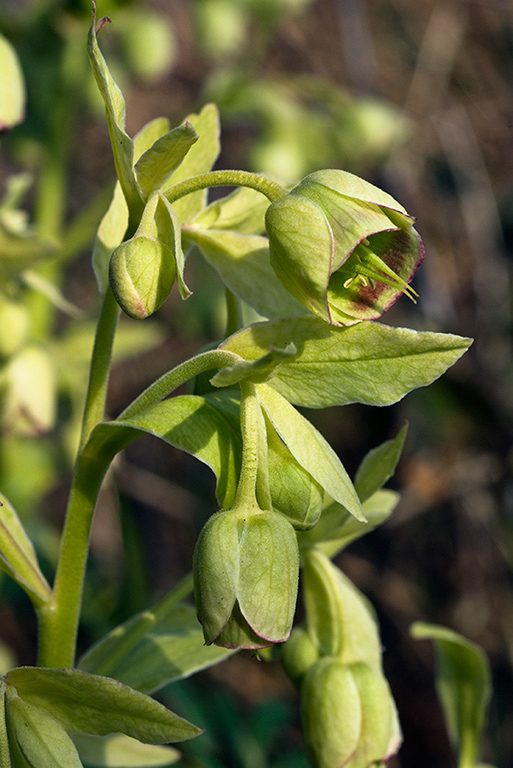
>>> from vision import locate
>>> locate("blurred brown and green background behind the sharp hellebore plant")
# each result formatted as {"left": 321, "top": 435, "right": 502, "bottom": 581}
{"left": 0, "top": 0, "right": 513, "bottom": 768}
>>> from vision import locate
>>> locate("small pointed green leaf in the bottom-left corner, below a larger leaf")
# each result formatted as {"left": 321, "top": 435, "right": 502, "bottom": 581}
{"left": 6, "top": 685, "right": 82, "bottom": 768}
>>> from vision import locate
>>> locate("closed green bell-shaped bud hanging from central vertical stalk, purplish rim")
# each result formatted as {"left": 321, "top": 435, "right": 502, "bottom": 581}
{"left": 194, "top": 503, "right": 299, "bottom": 648}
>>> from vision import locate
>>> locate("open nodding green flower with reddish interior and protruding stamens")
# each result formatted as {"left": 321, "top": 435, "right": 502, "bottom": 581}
{"left": 266, "top": 170, "right": 424, "bottom": 325}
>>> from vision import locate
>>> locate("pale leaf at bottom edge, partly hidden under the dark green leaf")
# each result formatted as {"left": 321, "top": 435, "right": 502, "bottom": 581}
{"left": 72, "top": 733, "right": 180, "bottom": 768}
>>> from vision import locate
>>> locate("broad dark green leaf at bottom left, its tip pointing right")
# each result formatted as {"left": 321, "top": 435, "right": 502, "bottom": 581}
{"left": 5, "top": 667, "right": 201, "bottom": 744}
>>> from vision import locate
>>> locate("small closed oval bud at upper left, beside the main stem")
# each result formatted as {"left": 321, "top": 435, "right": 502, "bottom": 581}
{"left": 109, "top": 235, "right": 176, "bottom": 320}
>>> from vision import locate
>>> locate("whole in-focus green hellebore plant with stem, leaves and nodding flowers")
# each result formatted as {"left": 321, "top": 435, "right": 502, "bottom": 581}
{"left": 0, "top": 9, "right": 486, "bottom": 768}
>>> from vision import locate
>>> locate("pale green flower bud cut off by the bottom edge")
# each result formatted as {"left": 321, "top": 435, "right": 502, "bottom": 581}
{"left": 301, "top": 656, "right": 401, "bottom": 768}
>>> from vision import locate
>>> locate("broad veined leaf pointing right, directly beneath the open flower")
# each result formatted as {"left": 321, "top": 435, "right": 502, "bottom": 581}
{"left": 220, "top": 318, "right": 472, "bottom": 408}
